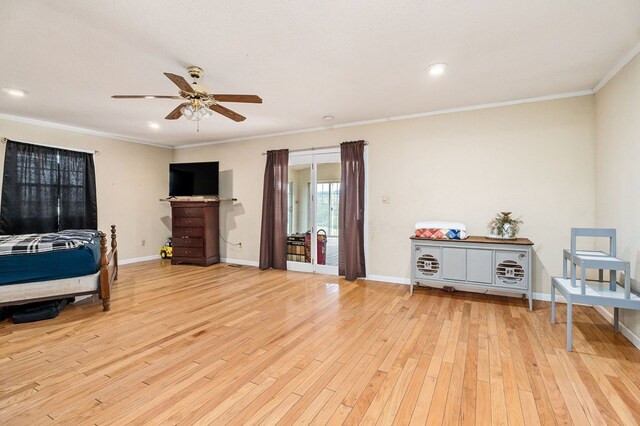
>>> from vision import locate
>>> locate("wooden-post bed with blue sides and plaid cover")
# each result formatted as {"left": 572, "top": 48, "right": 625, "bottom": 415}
{"left": 0, "top": 225, "right": 118, "bottom": 311}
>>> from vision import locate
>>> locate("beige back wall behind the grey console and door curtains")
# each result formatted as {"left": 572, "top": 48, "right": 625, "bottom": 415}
{"left": 174, "top": 96, "right": 595, "bottom": 293}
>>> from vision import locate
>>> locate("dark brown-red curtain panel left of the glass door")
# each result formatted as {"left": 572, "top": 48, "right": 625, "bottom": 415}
{"left": 259, "top": 149, "right": 289, "bottom": 271}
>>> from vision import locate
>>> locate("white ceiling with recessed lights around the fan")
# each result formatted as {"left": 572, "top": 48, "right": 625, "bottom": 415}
{"left": 0, "top": 0, "right": 640, "bottom": 146}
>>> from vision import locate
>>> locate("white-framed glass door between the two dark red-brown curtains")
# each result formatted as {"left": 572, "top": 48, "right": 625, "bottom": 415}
{"left": 287, "top": 150, "right": 340, "bottom": 275}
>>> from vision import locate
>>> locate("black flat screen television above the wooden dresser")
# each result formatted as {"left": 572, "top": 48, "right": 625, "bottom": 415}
{"left": 169, "top": 161, "right": 218, "bottom": 197}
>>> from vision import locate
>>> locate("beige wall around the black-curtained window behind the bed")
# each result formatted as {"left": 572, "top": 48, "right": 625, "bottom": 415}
{"left": 0, "top": 120, "right": 173, "bottom": 260}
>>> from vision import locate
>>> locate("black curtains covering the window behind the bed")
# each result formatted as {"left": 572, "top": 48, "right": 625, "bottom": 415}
{"left": 0, "top": 141, "right": 98, "bottom": 234}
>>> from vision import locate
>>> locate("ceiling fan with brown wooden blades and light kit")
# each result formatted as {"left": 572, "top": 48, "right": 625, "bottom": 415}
{"left": 111, "top": 66, "right": 262, "bottom": 121}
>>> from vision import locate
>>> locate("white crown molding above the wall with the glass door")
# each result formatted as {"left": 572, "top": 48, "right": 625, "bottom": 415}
{"left": 174, "top": 90, "right": 593, "bottom": 149}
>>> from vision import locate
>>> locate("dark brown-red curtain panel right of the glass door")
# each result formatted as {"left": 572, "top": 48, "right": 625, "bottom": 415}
{"left": 338, "top": 141, "right": 367, "bottom": 281}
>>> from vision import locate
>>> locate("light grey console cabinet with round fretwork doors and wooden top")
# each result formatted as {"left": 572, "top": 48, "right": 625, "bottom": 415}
{"left": 411, "top": 236, "right": 533, "bottom": 310}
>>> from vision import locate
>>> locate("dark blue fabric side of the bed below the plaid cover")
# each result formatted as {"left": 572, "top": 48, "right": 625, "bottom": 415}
{"left": 0, "top": 238, "right": 100, "bottom": 285}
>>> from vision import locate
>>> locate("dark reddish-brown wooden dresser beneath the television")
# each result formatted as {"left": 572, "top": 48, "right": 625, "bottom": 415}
{"left": 171, "top": 200, "right": 220, "bottom": 266}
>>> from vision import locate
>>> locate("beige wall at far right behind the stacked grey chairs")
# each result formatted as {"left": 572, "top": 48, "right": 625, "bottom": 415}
{"left": 596, "top": 55, "right": 640, "bottom": 335}
